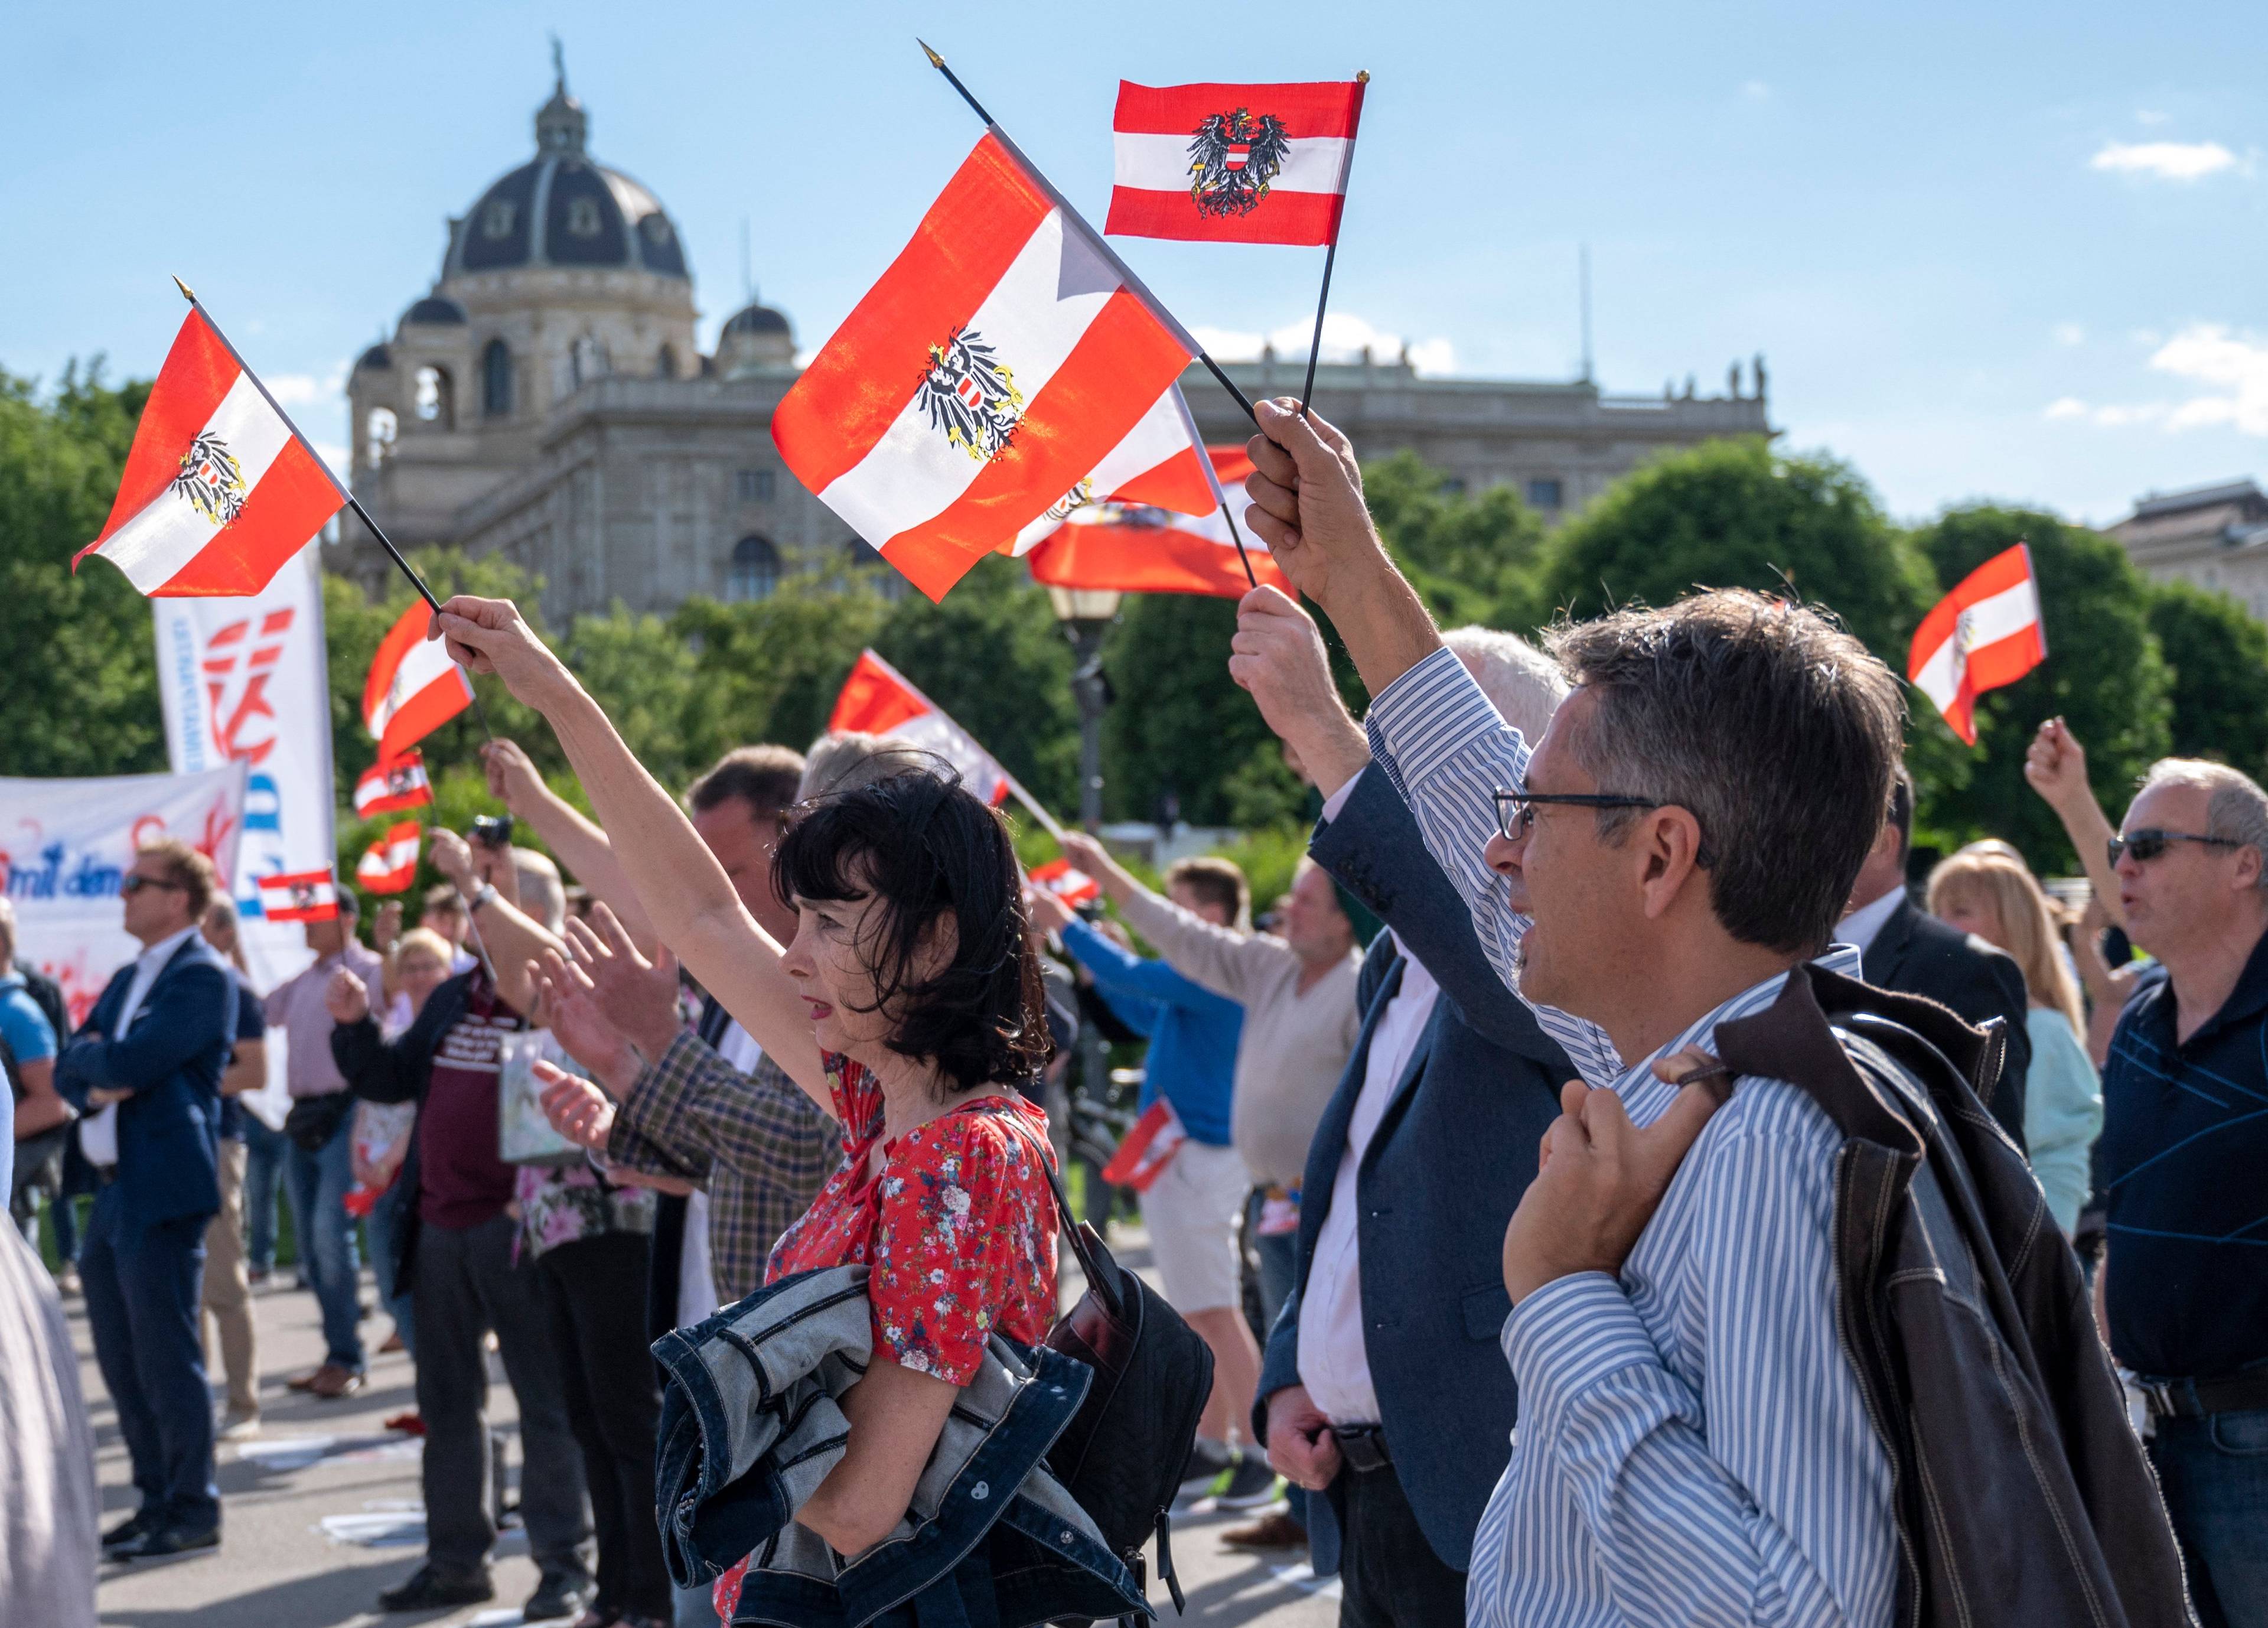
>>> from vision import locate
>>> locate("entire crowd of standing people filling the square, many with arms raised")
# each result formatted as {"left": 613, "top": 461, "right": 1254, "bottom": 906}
{"left": 0, "top": 403, "right": 2268, "bottom": 1628}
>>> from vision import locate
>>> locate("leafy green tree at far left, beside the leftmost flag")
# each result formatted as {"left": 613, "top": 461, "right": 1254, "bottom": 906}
{"left": 0, "top": 358, "right": 165, "bottom": 776}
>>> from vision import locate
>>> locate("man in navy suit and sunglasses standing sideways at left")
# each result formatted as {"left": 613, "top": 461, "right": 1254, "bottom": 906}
{"left": 54, "top": 836, "right": 236, "bottom": 1560}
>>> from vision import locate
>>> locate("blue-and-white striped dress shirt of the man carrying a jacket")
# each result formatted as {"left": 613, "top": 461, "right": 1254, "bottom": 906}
{"left": 1368, "top": 651, "right": 1898, "bottom": 1628}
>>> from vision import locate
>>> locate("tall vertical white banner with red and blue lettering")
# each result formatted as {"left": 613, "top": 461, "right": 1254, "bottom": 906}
{"left": 149, "top": 542, "right": 338, "bottom": 991}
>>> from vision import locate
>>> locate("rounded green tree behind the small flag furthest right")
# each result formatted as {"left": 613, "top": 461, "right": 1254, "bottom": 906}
{"left": 1898, "top": 503, "right": 2173, "bottom": 873}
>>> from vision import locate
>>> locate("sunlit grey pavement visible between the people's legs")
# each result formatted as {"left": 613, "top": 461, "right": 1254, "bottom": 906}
{"left": 71, "top": 1233, "right": 1338, "bottom": 1628}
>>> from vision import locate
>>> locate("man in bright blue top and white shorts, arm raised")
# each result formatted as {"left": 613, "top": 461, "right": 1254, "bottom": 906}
{"left": 1032, "top": 875, "right": 1277, "bottom": 1510}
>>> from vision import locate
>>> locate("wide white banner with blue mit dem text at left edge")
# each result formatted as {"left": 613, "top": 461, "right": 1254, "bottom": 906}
{"left": 0, "top": 762, "right": 252, "bottom": 1025}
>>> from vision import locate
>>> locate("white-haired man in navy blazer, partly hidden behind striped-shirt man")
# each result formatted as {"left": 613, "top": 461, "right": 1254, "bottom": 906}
{"left": 1231, "top": 617, "right": 1576, "bottom": 1628}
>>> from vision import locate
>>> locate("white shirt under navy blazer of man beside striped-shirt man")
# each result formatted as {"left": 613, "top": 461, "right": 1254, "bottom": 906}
{"left": 1299, "top": 943, "right": 1440, "bottom": 1424}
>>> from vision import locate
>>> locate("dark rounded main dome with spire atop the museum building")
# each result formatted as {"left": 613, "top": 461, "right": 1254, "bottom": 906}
{"left": 442, "top": 68, "right": 692, "bottom": 281}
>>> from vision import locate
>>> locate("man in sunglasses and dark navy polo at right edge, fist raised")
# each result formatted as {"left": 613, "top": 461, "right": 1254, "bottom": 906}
{"left": 2025, "top": 719, "right": 2268, "bottom": 1628}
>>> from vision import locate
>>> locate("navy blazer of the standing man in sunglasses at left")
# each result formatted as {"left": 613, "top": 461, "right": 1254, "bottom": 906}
{"left": 54, "top": 934, "right": 236, "bottom": 1227}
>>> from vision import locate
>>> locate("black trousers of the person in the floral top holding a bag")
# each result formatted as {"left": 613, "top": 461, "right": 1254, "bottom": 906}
{"left": 535, "top": 1231, "right": 669, "bottom": 1619}
